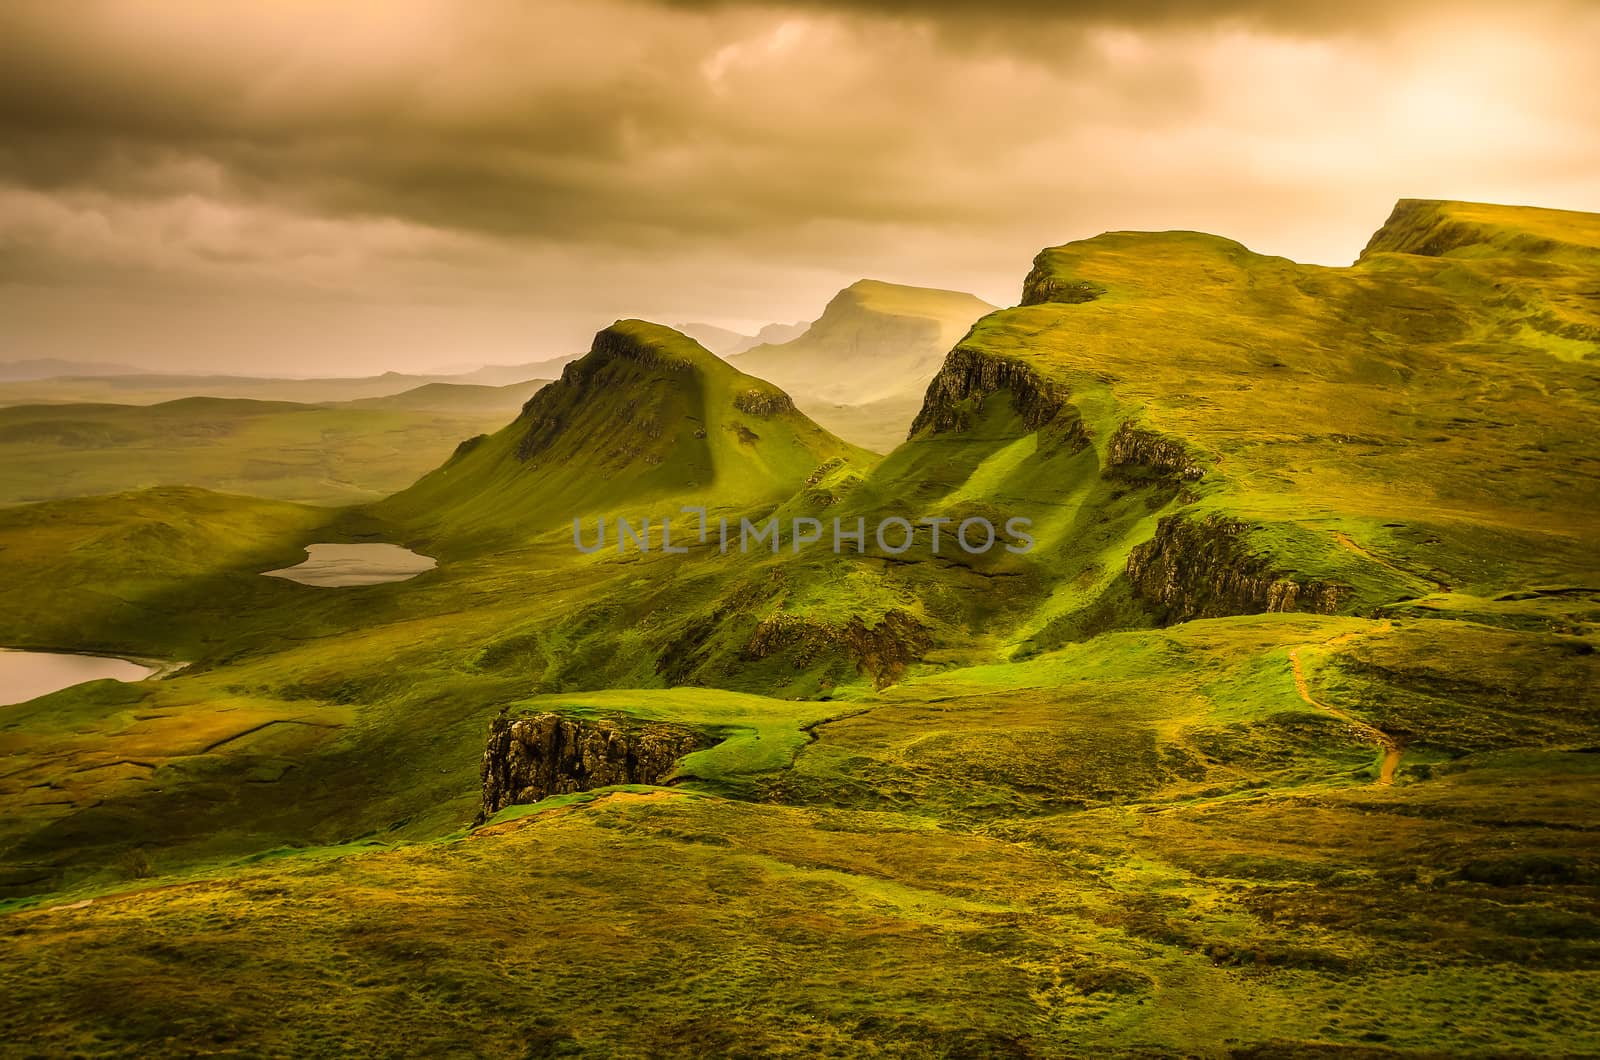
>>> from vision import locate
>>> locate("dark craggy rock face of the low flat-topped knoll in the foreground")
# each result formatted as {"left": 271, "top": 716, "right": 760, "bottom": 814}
{"left": 478, "top": 714, "right": 715, "bottom": 818}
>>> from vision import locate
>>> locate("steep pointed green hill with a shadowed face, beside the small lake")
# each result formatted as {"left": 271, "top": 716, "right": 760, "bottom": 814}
{"left": 381, "top": 320, "right": 872, "bottom": 547}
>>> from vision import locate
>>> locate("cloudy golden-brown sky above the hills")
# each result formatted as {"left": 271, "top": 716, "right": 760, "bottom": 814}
{"left": 0, "top": 0, "right": 1600, "bottom": 375}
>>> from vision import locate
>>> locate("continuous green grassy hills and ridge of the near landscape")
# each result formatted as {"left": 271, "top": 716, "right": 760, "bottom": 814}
{"left": 0, "top": 202, "right": 1600, "bottom": 1057}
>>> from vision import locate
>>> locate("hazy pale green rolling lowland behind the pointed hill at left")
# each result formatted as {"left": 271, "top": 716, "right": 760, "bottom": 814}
{"left": 0, "top": 379, "right": 544, "bottom": 504}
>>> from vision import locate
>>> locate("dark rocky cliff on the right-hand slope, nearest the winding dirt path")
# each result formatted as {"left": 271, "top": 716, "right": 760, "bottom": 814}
{"left": 1126, "top": 516, "right": 1350, "bottom": 624}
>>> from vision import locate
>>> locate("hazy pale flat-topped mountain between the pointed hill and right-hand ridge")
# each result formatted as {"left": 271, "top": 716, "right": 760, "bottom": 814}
{"left": 734, "top": 280, "right": 994, "bottom": 450}
